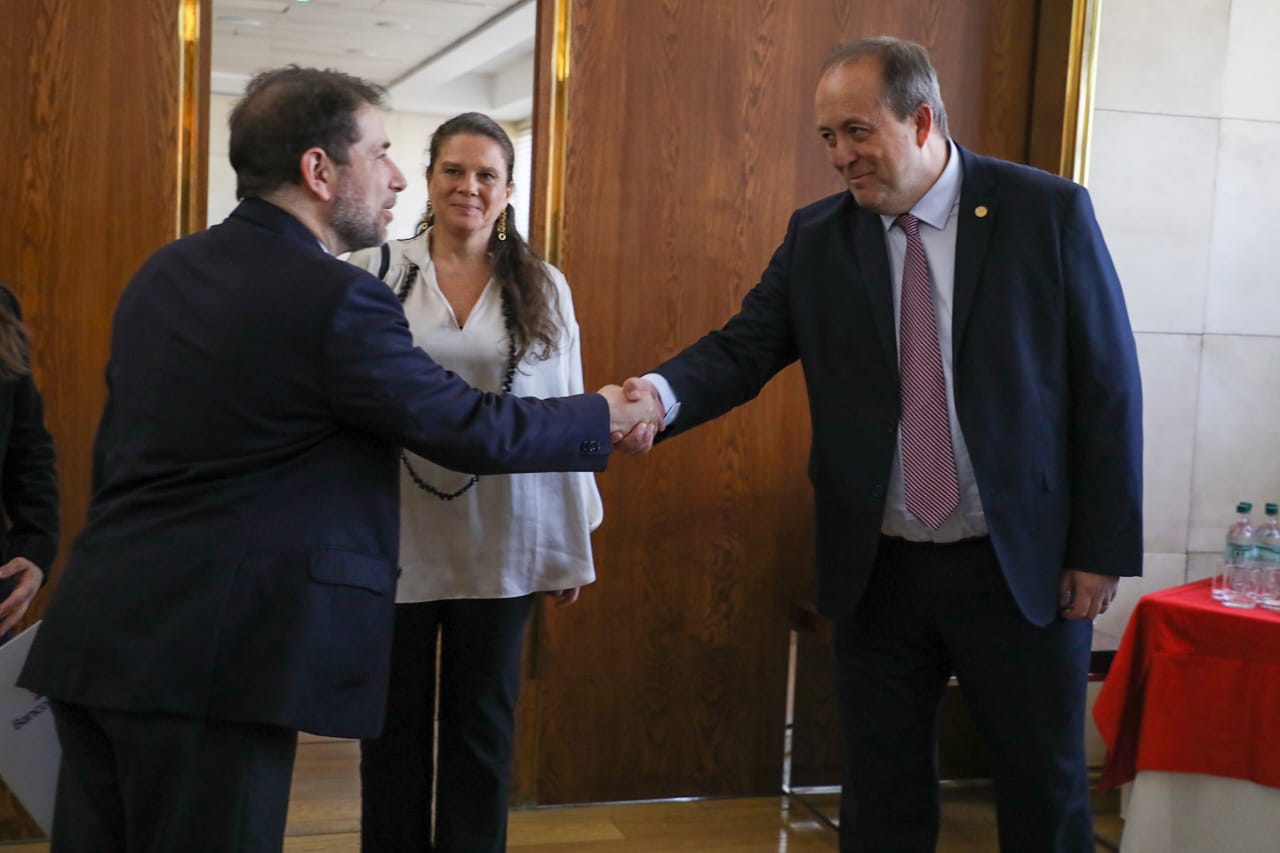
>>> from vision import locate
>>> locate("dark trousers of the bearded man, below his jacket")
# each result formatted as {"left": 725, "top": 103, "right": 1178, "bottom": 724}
{"left": 50, "top": 701, "right": 298, "bottom": 853}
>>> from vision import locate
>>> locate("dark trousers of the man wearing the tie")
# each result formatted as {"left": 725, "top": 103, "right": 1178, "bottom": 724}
{"left": 835, "top": 538, "right": 1094, "bottom": 853}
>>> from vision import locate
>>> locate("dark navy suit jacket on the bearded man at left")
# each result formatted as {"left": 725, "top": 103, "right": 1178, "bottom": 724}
{"left": 20, "top": 200, "right": 609, "bottom": 738}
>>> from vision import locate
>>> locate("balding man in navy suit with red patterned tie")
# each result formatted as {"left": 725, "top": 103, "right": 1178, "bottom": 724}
{"left": 622, "top": 37, "right": 1142, "bottom": 853}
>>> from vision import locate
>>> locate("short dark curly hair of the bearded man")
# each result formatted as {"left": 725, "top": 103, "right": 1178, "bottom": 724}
{"left": 228, "top": 65, "right": 385, "bottom": 199}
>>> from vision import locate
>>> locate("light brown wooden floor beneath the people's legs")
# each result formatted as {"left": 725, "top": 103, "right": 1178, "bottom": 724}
{"left": 0, "top": 739, "right": 1121, "bottom": 853}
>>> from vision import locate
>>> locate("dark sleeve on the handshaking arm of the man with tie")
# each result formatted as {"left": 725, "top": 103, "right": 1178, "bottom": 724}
{"left": 653, "top": 216, "right": 797, "bottom": 441}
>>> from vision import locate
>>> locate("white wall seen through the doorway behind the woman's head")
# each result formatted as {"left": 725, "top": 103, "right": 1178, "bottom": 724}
{"left": 209, "top": 95, "right": 530, "bottom": 238}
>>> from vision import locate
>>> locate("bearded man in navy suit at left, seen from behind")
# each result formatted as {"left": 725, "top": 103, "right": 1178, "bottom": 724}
{"left": 20, "top": 67, "right": 655, "bottom": 852}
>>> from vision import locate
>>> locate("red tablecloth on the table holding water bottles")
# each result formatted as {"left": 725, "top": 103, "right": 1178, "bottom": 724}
{"left": 1093, "top": 580, "right": 1280, "bottom": 790}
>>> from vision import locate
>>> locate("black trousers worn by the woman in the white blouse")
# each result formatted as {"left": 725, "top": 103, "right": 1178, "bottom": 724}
{"left": 360, "top": 596, "right": 534, "bottom": 853}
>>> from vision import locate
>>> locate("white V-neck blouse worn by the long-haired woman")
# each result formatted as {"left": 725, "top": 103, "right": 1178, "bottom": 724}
{"left": 348, "top": 232, "right": 604, "bottom": 603}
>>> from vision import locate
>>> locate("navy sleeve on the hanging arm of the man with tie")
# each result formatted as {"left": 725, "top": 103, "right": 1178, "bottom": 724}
{"left": 1061, "top": 188, "right": 1143, "bottom": 576}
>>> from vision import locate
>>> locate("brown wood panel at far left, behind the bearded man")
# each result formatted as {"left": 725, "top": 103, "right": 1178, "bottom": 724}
{"left": 0, "top": 0, "right": 209, "bottom": 838}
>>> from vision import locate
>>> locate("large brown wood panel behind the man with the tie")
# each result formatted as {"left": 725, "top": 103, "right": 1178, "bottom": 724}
{"left": 524, "top": 0, "right": 1037, "bottom": 803}
